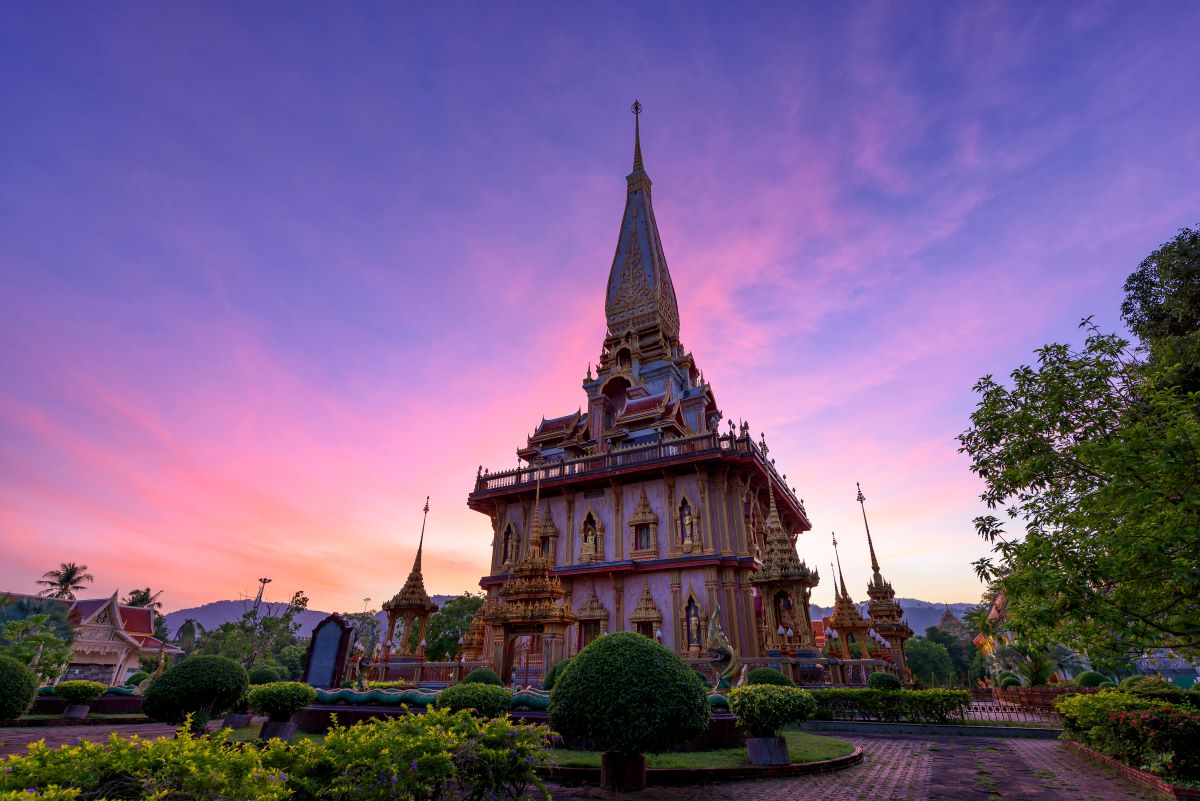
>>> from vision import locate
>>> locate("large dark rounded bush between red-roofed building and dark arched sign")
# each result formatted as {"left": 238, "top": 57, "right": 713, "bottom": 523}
{"left": 142, "top": 656, "right": 250, "bottom": 731}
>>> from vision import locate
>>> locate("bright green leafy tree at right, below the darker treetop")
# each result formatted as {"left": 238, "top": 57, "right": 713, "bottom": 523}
{"left": 959, "top": 321, "right": 1200, "bottom": 656}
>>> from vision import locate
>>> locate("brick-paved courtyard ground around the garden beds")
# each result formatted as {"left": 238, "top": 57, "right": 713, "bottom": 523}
{"left": 0, "top": 724, "right": 1163, "bottom": 801}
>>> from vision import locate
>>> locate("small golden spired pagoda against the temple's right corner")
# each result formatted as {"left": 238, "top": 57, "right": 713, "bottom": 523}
{"left": 749, "top": 484, "right": 821, "bottom": 652}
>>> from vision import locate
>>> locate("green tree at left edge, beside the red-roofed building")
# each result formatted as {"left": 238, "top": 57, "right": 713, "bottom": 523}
{"left": 0, "top": 596, "right": 74, "bottom": 681}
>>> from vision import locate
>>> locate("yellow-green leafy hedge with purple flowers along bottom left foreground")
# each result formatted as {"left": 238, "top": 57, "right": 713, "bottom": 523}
{"left": 0, "top": 710, "right": 551, "bottom": 801}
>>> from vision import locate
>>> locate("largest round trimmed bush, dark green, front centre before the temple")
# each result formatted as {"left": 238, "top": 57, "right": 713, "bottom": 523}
{"left": 550, "top": 632, "right": 712, "bottom": 757}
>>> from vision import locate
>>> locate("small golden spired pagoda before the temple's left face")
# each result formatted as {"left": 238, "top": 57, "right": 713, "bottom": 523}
{"left": 482, "top": 483, "right": 578, "bottom": 676}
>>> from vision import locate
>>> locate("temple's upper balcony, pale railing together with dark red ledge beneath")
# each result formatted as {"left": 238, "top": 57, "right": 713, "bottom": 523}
{"left": 467, "top": 432, "right": 811, "bottom": 530}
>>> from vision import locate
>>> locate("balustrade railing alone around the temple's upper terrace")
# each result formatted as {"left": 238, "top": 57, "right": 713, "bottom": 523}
{"left": 475, "top": 432, "right": 804, "bottom": 520}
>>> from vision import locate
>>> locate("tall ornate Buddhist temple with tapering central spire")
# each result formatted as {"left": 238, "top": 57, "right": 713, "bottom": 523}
{"left": 464, "top": 103, "right": 818, "bottom": 681}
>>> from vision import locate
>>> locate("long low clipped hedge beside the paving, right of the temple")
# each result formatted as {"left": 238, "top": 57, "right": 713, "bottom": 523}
{"left": 809, "top": 688, "right": 971, "bottom": 723}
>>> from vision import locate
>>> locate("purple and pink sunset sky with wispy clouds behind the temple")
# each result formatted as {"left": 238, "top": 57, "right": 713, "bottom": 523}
{"left": 0, "top": 2, "right": 1200, "bottom": 610}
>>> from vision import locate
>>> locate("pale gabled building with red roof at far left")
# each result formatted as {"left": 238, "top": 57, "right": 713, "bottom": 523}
{"left": 0, "top": 592, "right": 182, "bottom": 685}
